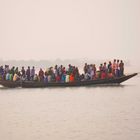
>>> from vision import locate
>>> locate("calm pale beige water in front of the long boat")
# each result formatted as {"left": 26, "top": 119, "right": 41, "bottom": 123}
{"left": 0, "top": 76, "right": 140, "bottom": 140}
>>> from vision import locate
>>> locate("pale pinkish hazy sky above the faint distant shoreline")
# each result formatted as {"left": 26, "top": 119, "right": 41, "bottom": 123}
{"left": 0, "top": 0, "right": 140, "bottom": 60}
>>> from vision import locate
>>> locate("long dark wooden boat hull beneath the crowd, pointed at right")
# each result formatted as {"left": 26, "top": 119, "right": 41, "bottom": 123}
{"left": 0, "top": 73, "right": 138, "bottom": 88}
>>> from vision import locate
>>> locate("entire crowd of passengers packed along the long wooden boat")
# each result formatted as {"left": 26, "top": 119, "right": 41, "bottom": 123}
{"left": 0, "top": 59, "right": 124, "bottom": 82}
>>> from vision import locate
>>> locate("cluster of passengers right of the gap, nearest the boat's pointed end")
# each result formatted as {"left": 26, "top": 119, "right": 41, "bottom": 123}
{"left": 84, "top": 59, "right": 124, "bottom": 80}
